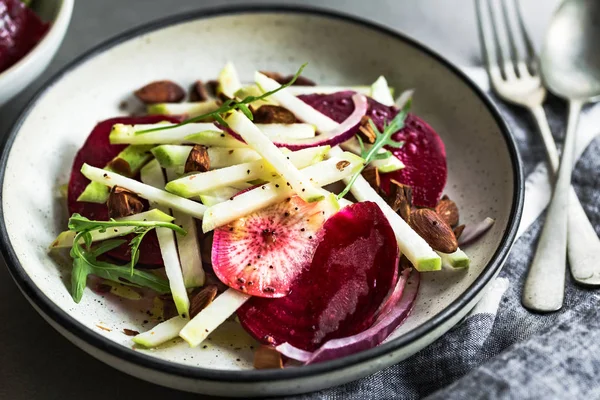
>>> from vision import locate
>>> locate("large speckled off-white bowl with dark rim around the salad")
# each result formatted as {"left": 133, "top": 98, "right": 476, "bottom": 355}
{"left": 0, "top": 7, "right": 523, "bottom": 397}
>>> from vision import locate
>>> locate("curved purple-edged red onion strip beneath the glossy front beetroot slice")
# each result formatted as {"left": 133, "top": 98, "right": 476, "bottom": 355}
{"left": 276, "top": 270, "right": 420, "bottom": 364}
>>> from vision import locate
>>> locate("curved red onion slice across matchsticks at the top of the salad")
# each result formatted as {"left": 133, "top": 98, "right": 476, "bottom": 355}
{"left": 227, "top": 93, "right": 369, "bottom": 150}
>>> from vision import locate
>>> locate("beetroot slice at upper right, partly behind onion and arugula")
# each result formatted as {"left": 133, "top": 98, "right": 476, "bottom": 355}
{"left": 298, "top": 91, "right": 448, "bottom": 207}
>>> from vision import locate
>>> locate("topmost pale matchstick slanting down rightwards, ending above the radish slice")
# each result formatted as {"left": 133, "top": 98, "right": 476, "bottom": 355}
{"left": 225, "top": 111, "right": 323, "bottom": 203}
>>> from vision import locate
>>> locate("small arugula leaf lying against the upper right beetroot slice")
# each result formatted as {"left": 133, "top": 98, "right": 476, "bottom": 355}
{"left": 337, "top": 100, "right": 411, "bottom": 199}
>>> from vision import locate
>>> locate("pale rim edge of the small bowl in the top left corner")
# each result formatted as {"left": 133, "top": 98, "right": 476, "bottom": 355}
{"left": 0, "top": 0, "right": 75, "bottom": 80}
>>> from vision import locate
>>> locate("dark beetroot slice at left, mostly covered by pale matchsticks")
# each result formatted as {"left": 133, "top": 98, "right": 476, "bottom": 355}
{"left": 68, "top": 115, "right": 180, "bottom": 266}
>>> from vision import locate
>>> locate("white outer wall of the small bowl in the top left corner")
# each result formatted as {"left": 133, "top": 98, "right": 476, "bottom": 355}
{"left": 0, "top": 0, "right": 75, "bottom": 106}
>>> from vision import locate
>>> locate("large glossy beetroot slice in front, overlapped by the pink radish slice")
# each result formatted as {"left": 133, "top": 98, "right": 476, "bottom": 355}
{"left": 238, "top": 202, "right": 398, "bottom": 351}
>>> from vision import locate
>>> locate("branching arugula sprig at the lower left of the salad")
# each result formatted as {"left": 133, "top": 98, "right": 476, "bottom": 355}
{"left": 69, "top": 214, "right": 186, "bottom": 303}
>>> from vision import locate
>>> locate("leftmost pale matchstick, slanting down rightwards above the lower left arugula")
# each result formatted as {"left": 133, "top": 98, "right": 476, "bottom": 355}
{"left": 81, "top": 164, "right": 206, "bottom": 219}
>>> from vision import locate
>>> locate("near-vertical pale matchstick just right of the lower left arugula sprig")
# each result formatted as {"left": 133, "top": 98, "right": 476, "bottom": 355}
{"left": 140, "top": 160, "right": 190, "bottom": 318}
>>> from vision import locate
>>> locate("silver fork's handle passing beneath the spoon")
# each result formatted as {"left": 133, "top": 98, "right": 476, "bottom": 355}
{"left": 530, "top": 105, "right": 600, "bottom": 286}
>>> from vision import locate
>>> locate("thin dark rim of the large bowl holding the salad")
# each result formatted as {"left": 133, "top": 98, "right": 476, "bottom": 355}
{"left": 0, "top": 5, "right": 524, "bottom": 383}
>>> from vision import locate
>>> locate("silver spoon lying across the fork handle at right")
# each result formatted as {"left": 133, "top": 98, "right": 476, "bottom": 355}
{"left": 522, "top": 0, "right": 600, "bottom": 311}
